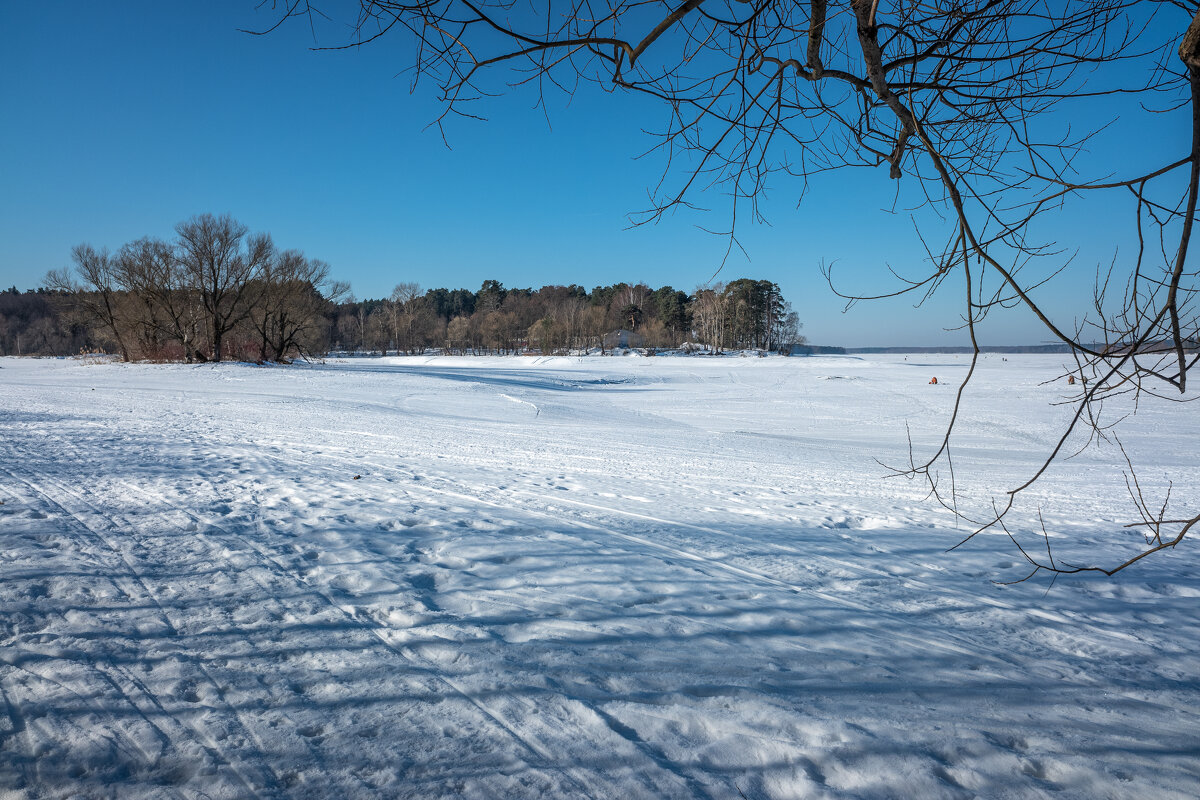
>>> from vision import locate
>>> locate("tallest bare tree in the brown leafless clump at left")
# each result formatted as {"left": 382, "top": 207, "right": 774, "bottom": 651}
{"left": 175, "top": 213, "right": 275, "bottom": 361}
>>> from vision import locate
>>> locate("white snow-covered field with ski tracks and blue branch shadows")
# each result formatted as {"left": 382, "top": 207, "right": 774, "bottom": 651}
{"left": 0, "top": 355, "right": 1200, "bottom": 799}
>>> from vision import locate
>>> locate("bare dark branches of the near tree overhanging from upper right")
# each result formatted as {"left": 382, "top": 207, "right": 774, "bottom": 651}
{"left": 264, "top": 0, "right": 1200, "bottom": 572}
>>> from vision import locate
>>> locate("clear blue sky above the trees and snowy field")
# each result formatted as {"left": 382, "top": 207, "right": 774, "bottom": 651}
{"left": 0, "top": 0, "right": 1187, "bottom": 345}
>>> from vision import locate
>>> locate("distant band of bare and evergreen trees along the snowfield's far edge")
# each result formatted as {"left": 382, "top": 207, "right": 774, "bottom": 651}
{"left": 0, "top": 215, "right": 804, "bottom": 363}
